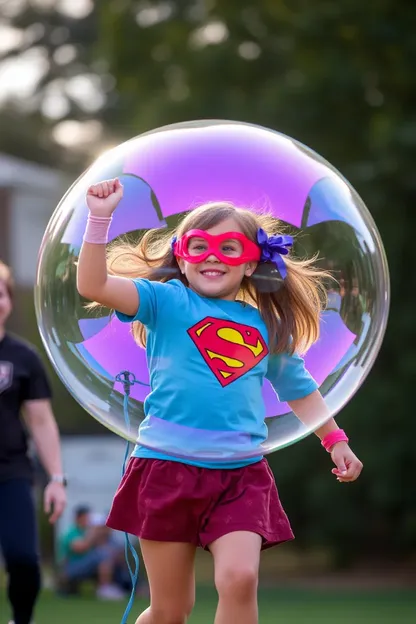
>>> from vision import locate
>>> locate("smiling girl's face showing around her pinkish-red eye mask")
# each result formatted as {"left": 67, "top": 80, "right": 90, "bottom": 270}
{"left": 178, "top": 218, "right": 257, "bottom": 301}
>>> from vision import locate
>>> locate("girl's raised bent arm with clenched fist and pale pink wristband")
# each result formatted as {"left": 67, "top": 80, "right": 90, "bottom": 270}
{"left": 77, "top": 179, "right": 139, "bottom": 316}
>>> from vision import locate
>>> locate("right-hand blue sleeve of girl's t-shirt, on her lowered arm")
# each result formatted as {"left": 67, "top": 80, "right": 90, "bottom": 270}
{"left": 266, "top": 353, "right": 319, "bottom": 402}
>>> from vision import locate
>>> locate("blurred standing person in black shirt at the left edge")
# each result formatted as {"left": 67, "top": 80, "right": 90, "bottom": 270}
{"left": 0, "top": 261, "right": 66, "bottom": 624}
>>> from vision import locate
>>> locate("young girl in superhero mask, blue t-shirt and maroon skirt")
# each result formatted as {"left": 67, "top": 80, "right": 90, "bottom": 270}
{"left": 77, "top": 179, "right": 362, "bottom": 624}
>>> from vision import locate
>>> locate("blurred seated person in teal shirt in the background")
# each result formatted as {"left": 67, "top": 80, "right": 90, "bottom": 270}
{"left": 60, "top": 506, "right": 125, "bottom": 600}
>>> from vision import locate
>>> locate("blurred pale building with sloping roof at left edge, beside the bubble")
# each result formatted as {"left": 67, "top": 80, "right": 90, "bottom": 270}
{"left": 0, "top": 153, "right": 71, "bottom": 287}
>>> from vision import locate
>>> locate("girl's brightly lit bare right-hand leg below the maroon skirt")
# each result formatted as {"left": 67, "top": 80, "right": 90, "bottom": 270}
{"left": 209, "top": 531, "right": 262, "bottom": 624}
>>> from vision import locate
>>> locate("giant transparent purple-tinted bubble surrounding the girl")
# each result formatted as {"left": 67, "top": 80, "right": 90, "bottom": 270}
{"left": 35, "top": 121, "right": 389, "bottom": 461}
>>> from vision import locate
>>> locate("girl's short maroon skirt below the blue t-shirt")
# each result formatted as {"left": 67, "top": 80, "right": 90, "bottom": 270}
{"left": 107, "top": 458, "right": 294, "bottom": 549}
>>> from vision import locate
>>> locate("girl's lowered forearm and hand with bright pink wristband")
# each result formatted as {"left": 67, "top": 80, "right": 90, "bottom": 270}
{"left": 288, "top": 390, "right": 363, "bottom": 482}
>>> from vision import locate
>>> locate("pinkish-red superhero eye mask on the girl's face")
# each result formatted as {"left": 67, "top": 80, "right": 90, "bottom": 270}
{"left": 172, "top": 230, "right": 261, "bottom": 266}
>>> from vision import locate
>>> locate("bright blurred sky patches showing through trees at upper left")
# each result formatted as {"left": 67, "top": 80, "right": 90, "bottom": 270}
{"left": 0, "top": 0, "right": 234, "bottom": 151}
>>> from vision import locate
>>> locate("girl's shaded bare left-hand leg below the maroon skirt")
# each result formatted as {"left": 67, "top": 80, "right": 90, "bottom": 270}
{"left": 136, "top": 540, "right": 197, "bottom": 624}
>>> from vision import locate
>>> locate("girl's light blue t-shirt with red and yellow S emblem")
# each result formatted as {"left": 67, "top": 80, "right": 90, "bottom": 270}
{"left": 117, "top": 279, "right": 318, "bottom": 468}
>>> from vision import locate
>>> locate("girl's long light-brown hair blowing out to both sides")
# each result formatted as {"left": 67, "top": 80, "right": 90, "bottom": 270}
{"left": 107, "top": 202, "right": 329, "bottom": 353}
